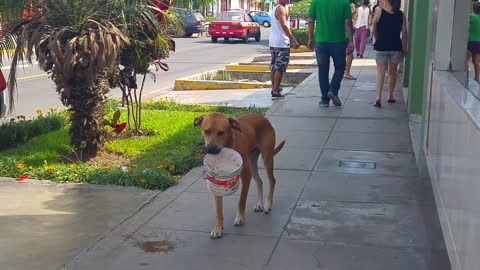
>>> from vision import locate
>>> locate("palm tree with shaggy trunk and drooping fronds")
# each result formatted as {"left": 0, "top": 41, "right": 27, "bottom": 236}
{"left": 0, "top": 0, "right": 174, "bottom": 158}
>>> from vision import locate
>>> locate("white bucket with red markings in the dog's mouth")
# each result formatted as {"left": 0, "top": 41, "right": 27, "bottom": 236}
{"left": 203, "top": 148, "right": 243, "bottom": 197}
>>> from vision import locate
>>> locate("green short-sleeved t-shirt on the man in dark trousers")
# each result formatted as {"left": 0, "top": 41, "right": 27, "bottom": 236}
{"left": 308, "top": 0, "right": 352, "bottom": 42}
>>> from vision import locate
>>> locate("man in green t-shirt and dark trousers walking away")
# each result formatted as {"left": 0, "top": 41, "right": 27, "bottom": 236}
{"left": 308, "top": 0, "right": 354, "bottom": 107}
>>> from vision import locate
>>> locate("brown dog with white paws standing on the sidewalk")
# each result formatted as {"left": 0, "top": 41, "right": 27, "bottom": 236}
{"left": 194, "top": 113, "right": 285, "bottom": 239}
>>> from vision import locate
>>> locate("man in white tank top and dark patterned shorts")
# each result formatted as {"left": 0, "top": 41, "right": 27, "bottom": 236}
{"left": 269, "top": 0, "right": 300, "bottom": 98}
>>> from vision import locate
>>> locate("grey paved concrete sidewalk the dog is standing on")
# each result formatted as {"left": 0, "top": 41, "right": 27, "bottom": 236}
{"left": 61, "top": 47, "right": 449, "bottom": 270}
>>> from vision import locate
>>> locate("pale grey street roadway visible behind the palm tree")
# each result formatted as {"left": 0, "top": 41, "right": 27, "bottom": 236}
{"left": 2, "top": 28, "right": 270, "bottom": 119}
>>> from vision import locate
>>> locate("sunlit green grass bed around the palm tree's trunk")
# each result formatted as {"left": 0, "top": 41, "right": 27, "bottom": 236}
{"left": 0, "top": 100, "right": 266, "bottom": 190}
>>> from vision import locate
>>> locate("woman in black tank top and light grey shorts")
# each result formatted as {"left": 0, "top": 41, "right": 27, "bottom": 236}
{"left": 373, "top": 0, "right": 408, "bottom": 108}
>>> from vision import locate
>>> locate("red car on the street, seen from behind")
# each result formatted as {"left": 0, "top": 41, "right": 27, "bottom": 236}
{"left": 208, "top": 10, "right": 261, "bottom": 43}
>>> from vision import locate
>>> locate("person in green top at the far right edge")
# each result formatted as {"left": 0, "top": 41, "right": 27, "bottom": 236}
{"left": 466, "top": 2, "right": 480, "bottom": 83}
